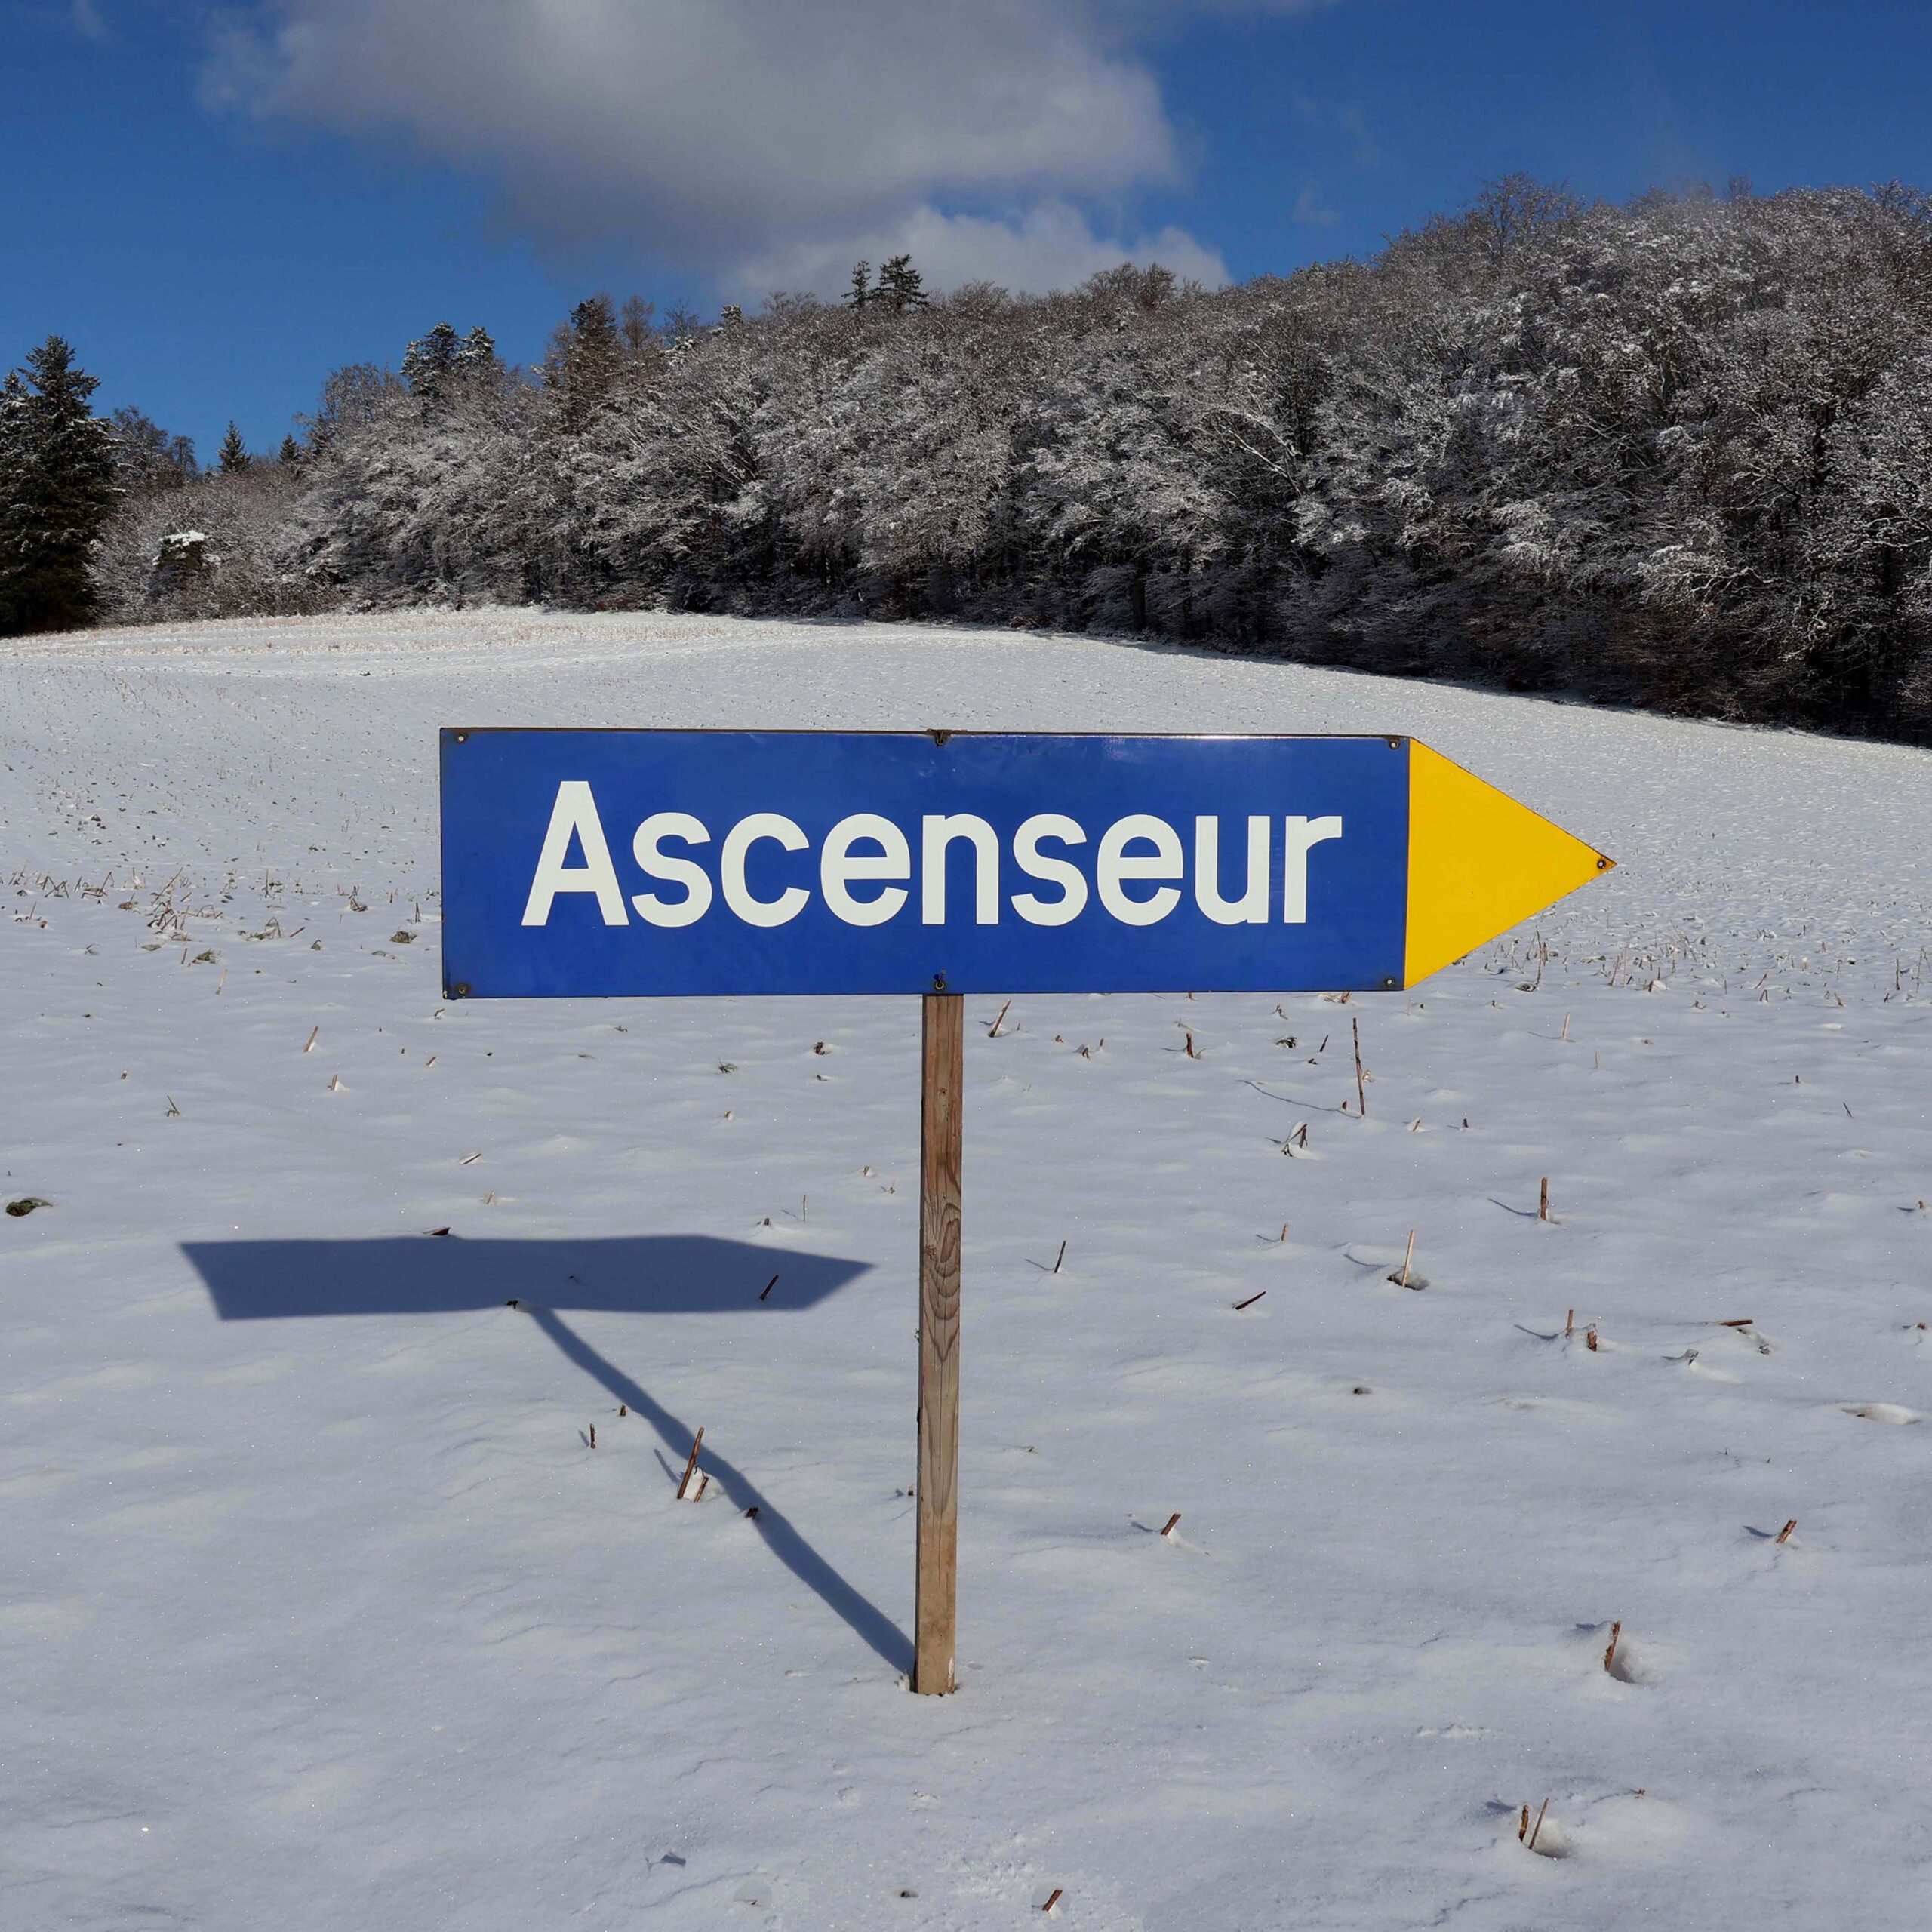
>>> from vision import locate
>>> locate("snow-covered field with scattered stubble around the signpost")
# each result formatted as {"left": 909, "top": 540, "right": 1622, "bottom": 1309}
{"left": 0, "top": 613, "right": 1932, "bottom": 1932}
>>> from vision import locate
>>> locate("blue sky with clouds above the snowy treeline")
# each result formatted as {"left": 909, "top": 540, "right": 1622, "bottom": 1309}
{"left": 11, "top": 0, "right": 1932, "bottom": 454}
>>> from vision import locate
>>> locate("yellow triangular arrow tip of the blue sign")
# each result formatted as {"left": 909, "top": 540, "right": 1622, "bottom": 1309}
{"left": 1403, "top": 738, "right": 1617, "bottom": 986}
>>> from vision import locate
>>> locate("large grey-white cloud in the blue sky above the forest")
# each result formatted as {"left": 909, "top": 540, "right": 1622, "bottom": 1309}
{"left": 203, "top": 0, "right": 1329, "bottom": 294}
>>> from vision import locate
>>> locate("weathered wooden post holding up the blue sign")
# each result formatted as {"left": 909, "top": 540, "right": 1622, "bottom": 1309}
{"left": 912, "top": 993, "right": 966, "bottom": 1694}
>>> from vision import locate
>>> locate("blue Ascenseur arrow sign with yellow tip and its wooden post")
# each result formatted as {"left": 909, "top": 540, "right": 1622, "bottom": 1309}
{"left": 442, "top": 728, "right": 1611, "bottom": 1693}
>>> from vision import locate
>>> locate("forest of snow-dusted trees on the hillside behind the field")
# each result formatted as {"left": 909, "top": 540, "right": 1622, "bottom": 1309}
{"left": 11, "top": 180, "right": 1932, "bottom": 738}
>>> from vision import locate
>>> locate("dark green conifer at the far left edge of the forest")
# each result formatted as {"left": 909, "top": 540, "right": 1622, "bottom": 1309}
{"left": 0, "top": 336, "right": 122, "bottom": 632}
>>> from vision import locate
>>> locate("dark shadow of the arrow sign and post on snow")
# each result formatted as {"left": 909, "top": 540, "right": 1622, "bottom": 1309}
{"left": 182, "top": 1235, "right": 912, "bottom": 1671}
